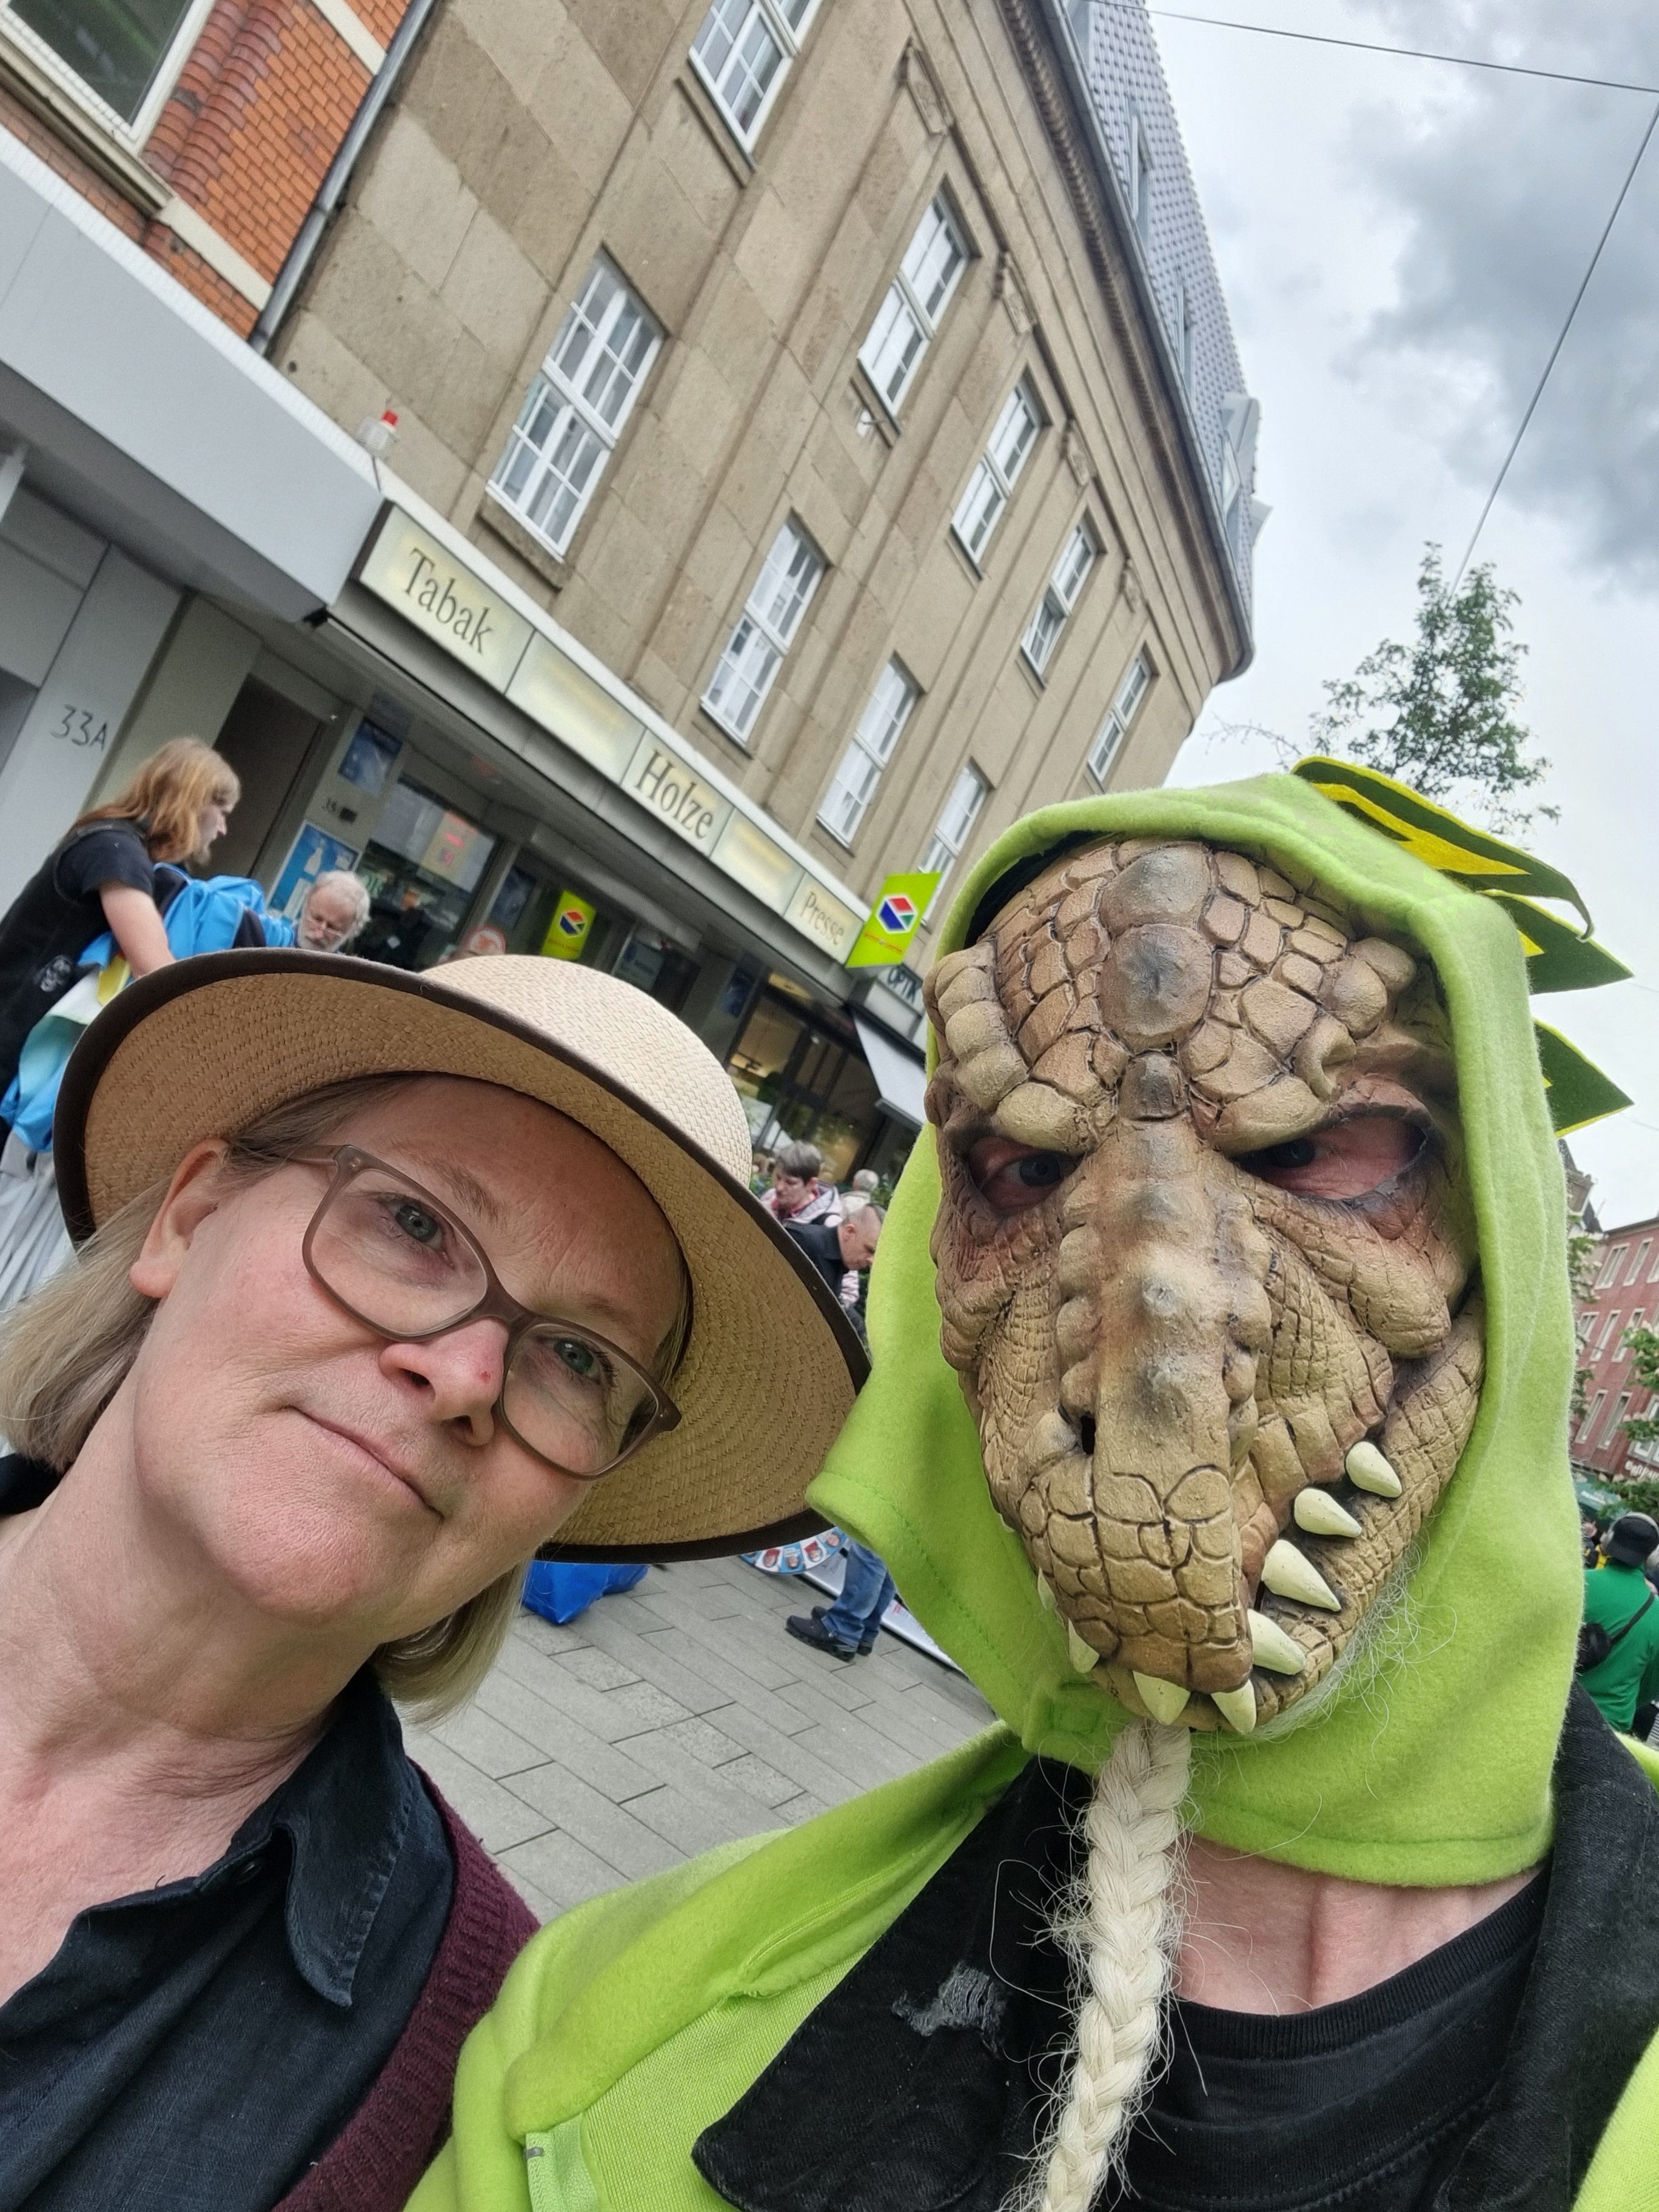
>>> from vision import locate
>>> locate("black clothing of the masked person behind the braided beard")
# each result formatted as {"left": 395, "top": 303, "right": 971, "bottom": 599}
{"left": 694, "top": 1690, "right": 1659, "bottom": 2212}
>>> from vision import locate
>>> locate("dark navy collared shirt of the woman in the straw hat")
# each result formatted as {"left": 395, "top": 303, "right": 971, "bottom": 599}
{"left": 0, "top": 1458, "right": 454, "bottom": 2212}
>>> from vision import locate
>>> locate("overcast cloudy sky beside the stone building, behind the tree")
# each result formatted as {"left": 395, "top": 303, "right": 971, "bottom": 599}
{"left": 1155, "top": 0, "right": 1659, "bottom": 1223}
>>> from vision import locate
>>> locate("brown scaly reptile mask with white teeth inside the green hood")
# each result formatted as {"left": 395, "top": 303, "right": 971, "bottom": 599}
{"left": 927, "top": 840, "right": 1482, "bottom": 1734}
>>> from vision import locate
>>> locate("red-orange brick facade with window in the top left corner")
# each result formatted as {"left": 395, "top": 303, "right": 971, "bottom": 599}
{"left": 0, "top": 0, "right": 409, "bottom": 338}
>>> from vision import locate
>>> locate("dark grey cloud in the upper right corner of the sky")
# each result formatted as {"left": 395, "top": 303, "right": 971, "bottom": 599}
{"left": 1354, "top": 0, "right": 1659, "bottom": 586}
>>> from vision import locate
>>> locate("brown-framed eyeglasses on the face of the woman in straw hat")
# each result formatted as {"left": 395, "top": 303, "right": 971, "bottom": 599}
{"left": 287, "top": 1144, "right": 679, "bottom": 1482}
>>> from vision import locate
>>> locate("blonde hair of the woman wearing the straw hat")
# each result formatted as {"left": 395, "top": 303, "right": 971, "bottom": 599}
{"left": 0, "top": 1075, "right": 525, "bottom": 1718}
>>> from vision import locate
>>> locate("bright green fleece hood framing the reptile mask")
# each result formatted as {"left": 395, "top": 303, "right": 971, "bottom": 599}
{"left": 809, "top": 776, "right": 1580, "bottom": 1885}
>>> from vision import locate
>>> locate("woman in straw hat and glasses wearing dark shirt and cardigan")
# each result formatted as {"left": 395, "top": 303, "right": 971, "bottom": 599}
{"left": 0, "top": 951, "right": 860, "bottom": 2212}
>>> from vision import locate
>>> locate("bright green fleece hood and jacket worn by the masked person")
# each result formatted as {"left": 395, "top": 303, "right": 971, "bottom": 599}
{"left": 395, "top": 776, "right": 1659, "bottom": 2212}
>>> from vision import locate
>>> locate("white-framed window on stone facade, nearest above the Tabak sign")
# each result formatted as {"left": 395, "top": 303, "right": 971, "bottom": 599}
{"left": 491, "top": 255, "right": 662, "bottom": 553}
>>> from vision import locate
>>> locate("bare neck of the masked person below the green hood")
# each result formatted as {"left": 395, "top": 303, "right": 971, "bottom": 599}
{"left": 1175, "top": 1838, "right": 1530, "bottom": 2013}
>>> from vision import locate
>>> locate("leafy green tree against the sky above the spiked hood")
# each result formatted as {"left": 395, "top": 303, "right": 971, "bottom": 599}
{"left": 1310, "top": 544, "right": 1557, "bottom": 836}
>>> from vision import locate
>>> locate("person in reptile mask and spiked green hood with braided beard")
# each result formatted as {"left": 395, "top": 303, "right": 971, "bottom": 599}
{"left": 414, "top": 761, "right": 1659, "bottom": 2212}
